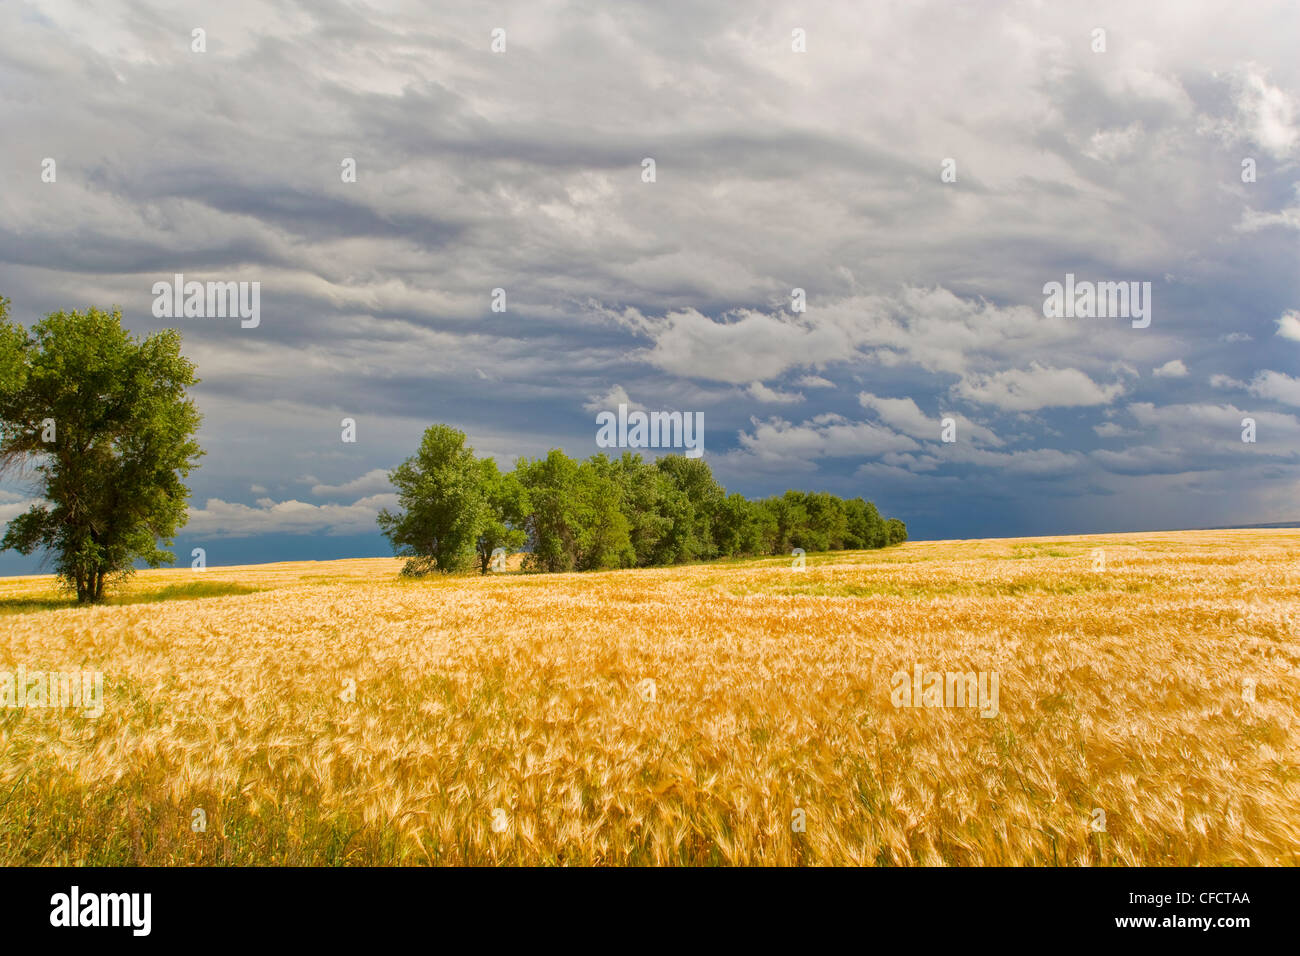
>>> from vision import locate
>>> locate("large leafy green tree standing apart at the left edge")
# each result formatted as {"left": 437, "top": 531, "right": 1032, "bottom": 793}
{"left": 0, "top": 299, "right": 203, "bottom": 602}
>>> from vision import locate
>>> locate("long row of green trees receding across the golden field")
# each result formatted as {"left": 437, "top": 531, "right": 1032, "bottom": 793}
{"left": 378, "top": 424, "right": 907, "bottom": 575}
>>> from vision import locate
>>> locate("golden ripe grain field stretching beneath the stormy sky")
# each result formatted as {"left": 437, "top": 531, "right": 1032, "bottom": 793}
{"left": 0, "top": 531, "right": 1300, "bottom": 865}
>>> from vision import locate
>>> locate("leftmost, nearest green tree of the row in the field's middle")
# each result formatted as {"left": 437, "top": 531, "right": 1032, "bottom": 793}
{"left": 378, "top": 425, "right": 490, "bottom": 575}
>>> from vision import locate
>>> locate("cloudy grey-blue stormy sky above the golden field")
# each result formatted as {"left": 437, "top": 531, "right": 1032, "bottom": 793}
{"left": 0, "top": 0, "right": 1300, "bottom": 571}
